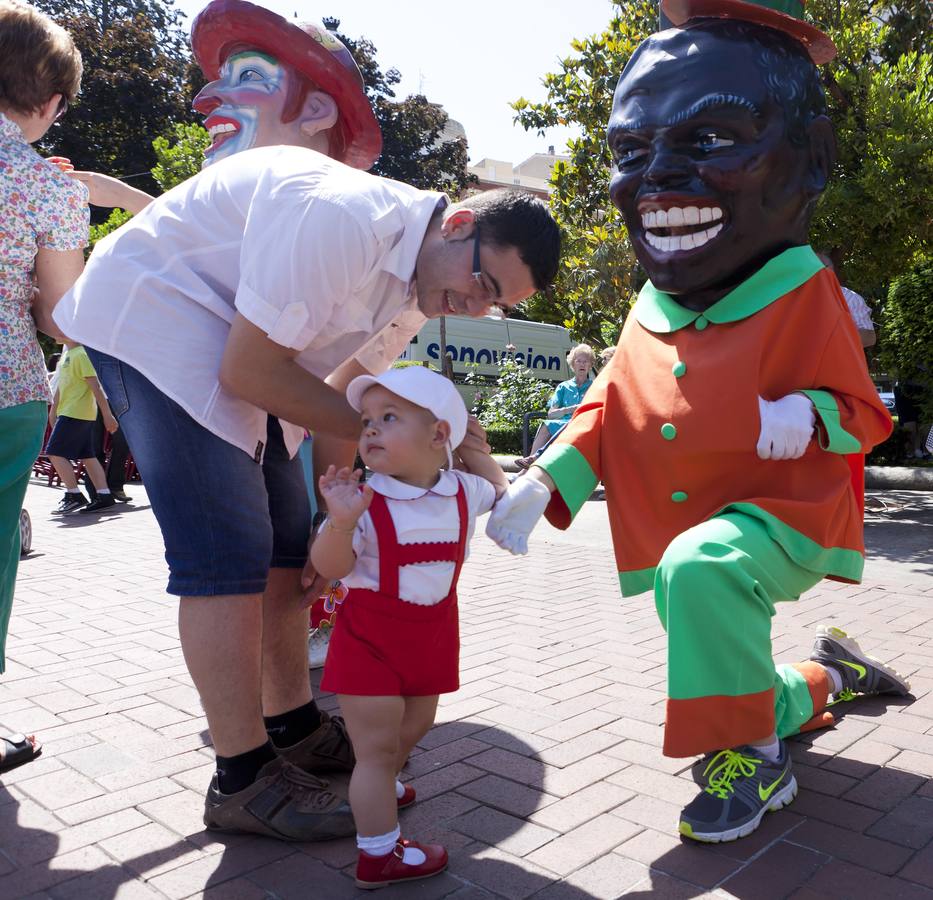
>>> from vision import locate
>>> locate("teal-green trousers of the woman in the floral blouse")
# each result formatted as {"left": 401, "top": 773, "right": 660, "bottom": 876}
{"left": 0, "top": 400, "right": 49, "bottom": 672}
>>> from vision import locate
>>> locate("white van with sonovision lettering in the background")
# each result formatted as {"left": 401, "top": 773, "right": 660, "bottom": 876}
{"left": 399, "top": 316, "right": 573, "bottom": 405}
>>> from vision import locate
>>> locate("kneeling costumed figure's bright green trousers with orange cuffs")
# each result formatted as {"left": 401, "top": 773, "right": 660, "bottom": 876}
{"left": 654, "top": 512, "right": 826, "bottom": 756}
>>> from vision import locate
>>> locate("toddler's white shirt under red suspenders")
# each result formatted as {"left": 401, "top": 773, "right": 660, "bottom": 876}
{"left": 341, "top": 470, "right": 496, "bottom": 606}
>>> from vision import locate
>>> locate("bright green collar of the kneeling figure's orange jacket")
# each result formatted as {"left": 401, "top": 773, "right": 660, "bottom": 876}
{"left": 632, "top": 246, "right": 823, "bottom": 334}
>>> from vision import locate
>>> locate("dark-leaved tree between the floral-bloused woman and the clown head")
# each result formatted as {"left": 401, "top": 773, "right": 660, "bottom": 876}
{"left": 37, "top": 0, "right": 196, "bottom": 192}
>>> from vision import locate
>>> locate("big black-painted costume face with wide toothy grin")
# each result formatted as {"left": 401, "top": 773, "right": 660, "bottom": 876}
{"left": 608, "top": 29, "right": 812, "bottom": 309}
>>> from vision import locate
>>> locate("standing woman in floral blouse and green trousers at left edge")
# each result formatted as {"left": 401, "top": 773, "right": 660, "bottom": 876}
{"left": 0, "top": 0, "right": 88, "bottom": 772}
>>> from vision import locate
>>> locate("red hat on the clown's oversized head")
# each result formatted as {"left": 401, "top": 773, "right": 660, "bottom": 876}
{"left": 191, "top": 0, "right": 382, "bottom": 169}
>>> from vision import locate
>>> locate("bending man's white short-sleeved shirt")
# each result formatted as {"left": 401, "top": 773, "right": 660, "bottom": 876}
{"left": 55, "top": 147, "right": 447, "bottom": 459}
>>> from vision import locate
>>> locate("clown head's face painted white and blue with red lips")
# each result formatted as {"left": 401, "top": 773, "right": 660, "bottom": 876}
{"left": 193, "top": 50, "right": 305, "bottom": 166}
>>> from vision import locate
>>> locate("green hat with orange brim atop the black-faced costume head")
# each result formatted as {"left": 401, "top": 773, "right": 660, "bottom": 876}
{"left": 661, "top": 0, "right": 836, "bottom": 65}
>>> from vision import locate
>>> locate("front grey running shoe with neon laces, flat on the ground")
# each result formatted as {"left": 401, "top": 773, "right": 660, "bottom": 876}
{"left": 679, "top": 741, "right": 797, "bottom": 844}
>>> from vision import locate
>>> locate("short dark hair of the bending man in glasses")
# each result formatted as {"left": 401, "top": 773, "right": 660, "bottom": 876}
{"left": 455, "top": 188, "right": 560, "bottom": 291}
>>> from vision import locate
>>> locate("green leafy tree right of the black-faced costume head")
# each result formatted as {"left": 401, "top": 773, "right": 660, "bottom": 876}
{"left": 807, "top": 0, "right": 933, "bottom": 298}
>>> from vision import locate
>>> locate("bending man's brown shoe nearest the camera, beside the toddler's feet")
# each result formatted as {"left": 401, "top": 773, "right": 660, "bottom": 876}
{"left": 204, "top": 757, "right": 356, "bottom": 841}
